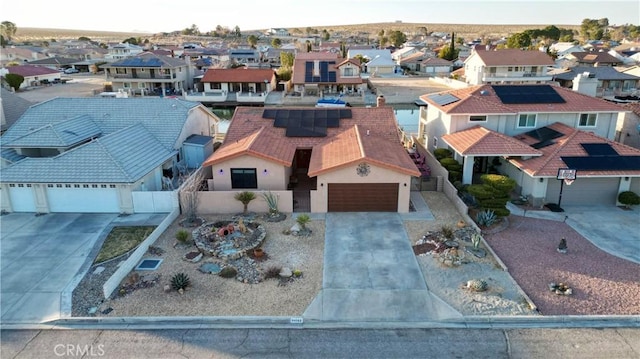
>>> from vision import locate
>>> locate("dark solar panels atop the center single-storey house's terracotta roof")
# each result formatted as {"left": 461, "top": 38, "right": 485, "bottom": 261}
{"left": 262, "top": 109, "right": 352, "bottom": 137}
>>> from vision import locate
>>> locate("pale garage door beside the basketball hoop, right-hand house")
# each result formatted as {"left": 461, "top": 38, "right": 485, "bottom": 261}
{"left": 547, "top": 174, "right": 620, "bottom": 206}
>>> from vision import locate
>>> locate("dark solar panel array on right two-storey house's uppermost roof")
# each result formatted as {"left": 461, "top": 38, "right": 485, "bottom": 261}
{"left": 491, "top": 85, "right": 565, "bottom": 105}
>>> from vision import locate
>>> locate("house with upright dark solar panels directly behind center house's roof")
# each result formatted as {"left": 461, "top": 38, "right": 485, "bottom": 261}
{"left": 289, "top": 52, "right": 364, "bottom": 96}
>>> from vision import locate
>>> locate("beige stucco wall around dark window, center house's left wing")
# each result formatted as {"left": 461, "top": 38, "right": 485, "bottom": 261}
{"left": 211, "top": 155, "right": 291, "bottom": 191}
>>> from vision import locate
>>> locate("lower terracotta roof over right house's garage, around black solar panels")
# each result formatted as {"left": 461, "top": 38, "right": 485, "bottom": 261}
{"left": 510, "top": 122, "right": 640, "bottom": 179}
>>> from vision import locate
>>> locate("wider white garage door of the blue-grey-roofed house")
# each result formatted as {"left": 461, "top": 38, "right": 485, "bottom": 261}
{"left": 47, "top": 187, "right": 120, "bottom": 213}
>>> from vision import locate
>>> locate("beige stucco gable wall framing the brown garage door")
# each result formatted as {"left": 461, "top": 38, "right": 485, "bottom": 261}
{"left": 311, "top": 163, "right": 411, "bottom": 213}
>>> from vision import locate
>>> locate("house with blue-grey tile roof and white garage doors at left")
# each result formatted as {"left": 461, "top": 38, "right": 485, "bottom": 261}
{"left": 0, "top": 97, "right": 217, "bottom": 213}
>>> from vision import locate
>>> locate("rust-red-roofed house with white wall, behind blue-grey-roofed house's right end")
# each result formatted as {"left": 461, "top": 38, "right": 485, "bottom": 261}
{"left": 185, "top": 68, "right": 276, "bottom": 104}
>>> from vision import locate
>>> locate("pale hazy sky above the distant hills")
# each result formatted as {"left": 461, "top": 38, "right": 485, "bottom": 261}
{"left": 0, "top": 0, "right": 640, "bottom": 33}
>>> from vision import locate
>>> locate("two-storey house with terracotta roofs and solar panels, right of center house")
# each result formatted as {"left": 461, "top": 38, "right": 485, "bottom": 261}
{"left": 418, "top": 84, "right": 640, "bottom": 206}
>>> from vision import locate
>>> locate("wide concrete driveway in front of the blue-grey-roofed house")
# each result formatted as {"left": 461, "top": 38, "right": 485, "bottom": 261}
{"left": 0, "top": 213, "right": 165, "bottom": 324}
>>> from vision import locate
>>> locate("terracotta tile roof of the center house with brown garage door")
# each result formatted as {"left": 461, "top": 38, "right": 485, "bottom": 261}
{"left": 203, "top": 106, "right": 420, "bottom": 176}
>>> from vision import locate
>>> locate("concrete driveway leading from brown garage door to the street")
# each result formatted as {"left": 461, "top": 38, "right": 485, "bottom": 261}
{"left": 303, "top": 213, "right": 460, "bottom": 321}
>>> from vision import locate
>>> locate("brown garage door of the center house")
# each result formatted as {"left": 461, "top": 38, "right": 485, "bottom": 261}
{"left": 329, "top": 183, "right": 398, "bottom": 212}
